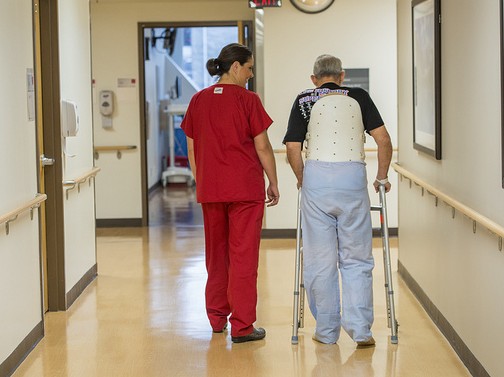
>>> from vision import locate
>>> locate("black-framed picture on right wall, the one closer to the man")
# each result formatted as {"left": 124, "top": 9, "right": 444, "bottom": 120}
{"left": 411, "top": 0, "right": 441, "bottom": 160}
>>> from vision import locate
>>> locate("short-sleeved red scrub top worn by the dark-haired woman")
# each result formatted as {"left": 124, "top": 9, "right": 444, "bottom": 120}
{"left": 181, "top": 84, "right": 273, "bottom": 203}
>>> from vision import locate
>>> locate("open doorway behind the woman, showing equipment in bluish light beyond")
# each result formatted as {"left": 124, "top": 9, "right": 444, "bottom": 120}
{"left": 138, "top": 21, "right": 255, "bottom": 226}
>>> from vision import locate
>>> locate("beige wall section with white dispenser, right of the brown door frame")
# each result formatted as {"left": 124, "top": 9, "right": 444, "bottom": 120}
{"left": 58, "top": 0, "right": 97, "bottom": 292}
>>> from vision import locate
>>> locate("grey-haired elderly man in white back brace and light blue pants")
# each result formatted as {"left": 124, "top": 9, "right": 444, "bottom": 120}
{"left": 283, "top": 55, "right": 392, "bottom": 348}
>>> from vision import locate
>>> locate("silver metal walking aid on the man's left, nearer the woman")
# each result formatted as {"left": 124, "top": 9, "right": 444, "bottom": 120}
{"left": 291, "top": 189, "right": 305, "bottom": 344}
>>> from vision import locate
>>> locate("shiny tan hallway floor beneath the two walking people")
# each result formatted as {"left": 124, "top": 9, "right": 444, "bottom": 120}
{"left": 14, "top": 188, "right": 470, "bottom": 377}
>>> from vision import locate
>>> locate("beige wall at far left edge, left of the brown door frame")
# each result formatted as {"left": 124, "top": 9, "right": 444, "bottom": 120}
{"left": 0, "top": 0, "right": 42, "bottom": 363}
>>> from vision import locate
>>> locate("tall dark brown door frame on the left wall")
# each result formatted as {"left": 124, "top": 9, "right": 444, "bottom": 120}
{"left": 34, "top": 0, "right": 67, "bottom": 312}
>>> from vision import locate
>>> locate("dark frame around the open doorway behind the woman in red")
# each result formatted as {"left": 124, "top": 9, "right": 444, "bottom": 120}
{"left": 138, "top": 21, "right": 256, "bottom": 226}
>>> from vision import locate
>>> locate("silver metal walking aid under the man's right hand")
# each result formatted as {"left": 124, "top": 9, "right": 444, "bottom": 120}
{"left": 371, "top": 185, "right": 399, "bottom": 344}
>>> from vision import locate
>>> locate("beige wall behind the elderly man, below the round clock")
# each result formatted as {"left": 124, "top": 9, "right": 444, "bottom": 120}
{"left": 264, "top": 0, "right": 397, "bottom": 229}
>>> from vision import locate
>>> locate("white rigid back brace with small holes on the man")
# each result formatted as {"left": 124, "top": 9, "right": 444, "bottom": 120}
{"left": 306, "top": 94, "right": 366, "bottom": 162}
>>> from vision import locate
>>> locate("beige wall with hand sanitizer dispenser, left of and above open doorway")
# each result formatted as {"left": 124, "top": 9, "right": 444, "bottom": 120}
{"left": 91, "top": 1, "right": 254, "bottom": 219}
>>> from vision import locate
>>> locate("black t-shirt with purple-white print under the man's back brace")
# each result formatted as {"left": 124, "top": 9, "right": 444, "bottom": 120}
{"left": 283, "top": 82, "right": 384, "bottom": 144}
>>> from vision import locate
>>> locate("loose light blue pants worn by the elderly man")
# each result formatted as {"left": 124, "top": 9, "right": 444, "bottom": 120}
{"left": 301, "top": 160, "right": 374, "bottom": 343}
